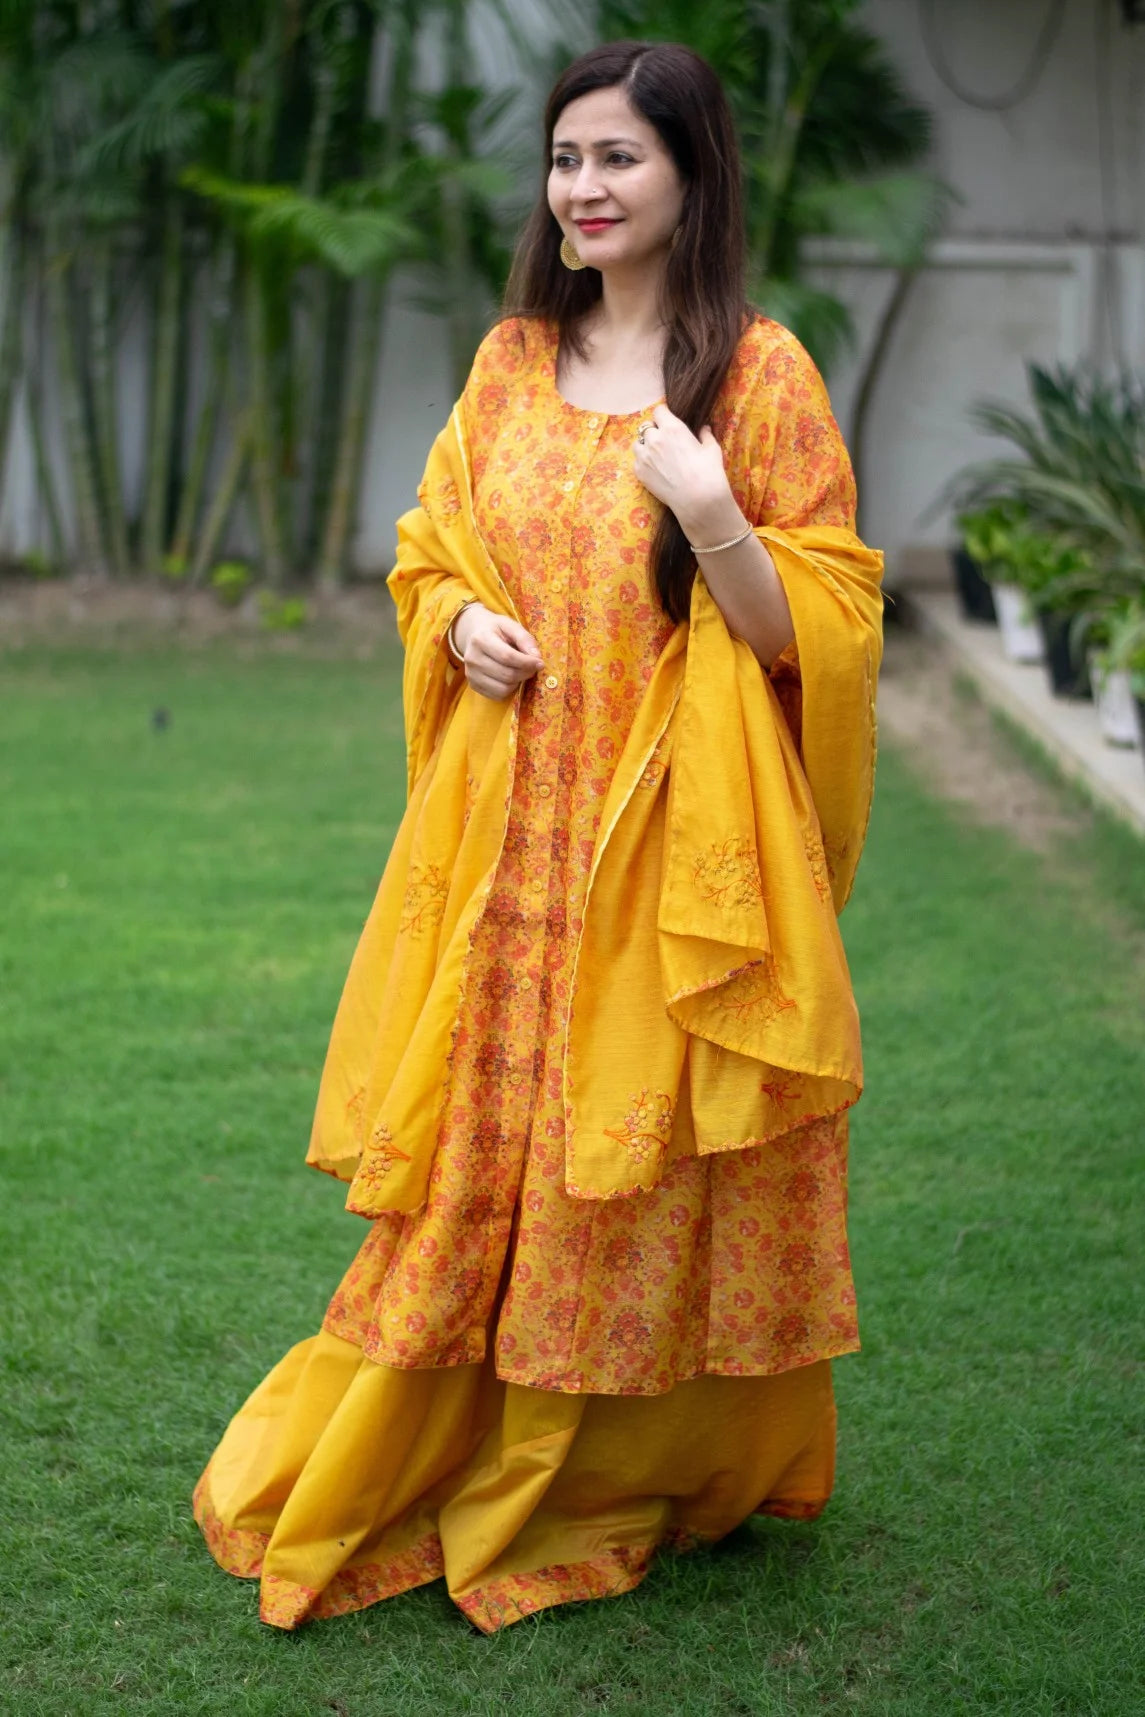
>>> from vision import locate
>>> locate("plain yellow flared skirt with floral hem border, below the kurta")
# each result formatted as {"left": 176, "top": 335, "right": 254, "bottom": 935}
{"left": 196, "top": 1332, "right": 834, "bottom": 1633}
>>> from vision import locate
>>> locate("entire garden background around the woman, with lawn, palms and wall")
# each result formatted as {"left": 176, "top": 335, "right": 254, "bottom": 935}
{"left": 0, "top": 0, "right": 1145, "bottom": 1717}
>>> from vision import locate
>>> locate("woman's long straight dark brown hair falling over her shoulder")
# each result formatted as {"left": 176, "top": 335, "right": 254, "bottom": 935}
{"left": 505, "top": 41, "right": 748, "bottom": 620}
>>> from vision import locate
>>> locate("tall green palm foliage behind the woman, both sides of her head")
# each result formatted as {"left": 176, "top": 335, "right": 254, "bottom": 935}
{"left": 0, "top": 0, "right": 948, "bottom": 587}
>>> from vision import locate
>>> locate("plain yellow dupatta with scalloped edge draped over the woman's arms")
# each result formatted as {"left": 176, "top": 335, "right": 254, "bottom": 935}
{"left": 307, "top": 412, "right": 882, "bottom": 1216}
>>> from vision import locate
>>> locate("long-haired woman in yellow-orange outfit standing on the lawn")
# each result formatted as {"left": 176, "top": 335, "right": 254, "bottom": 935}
{"left": 196, "top": 33, "right": 881, "bottom": 1631}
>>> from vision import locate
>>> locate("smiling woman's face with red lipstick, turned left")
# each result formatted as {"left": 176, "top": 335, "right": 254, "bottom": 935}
{"left": 549, "top": 88, "right": 683, "bottom": 271}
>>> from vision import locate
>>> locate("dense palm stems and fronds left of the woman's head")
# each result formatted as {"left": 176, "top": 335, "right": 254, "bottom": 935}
{"left": 0, "top": 0, "right": 536, "bottom": 584}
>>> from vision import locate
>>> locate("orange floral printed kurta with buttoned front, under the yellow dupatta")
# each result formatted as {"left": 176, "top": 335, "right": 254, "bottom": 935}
{"left": 326, "top": 318, "right": 858, "bottom": 1394}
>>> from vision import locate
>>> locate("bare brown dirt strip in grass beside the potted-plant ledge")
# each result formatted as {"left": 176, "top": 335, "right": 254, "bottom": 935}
{"left": 879, "top": 627, "right": 1094, "bottom": 852}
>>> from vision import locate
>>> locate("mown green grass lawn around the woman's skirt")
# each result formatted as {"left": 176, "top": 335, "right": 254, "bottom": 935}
{"left": 0, "top": 647, "right": 1145, "bottom": 1717}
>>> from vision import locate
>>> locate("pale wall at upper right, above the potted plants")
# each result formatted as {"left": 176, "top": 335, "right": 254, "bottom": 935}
{"left": 819, "top": 0, "right": 1145, "bottom": 582}
